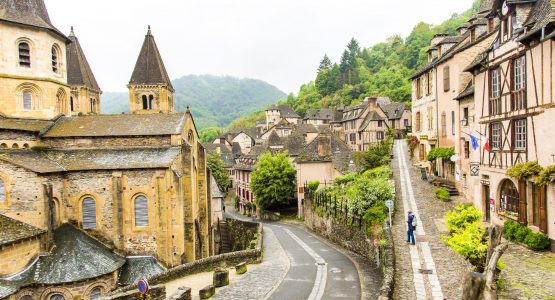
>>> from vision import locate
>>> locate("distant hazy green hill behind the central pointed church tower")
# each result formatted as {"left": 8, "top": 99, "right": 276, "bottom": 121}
{"left": 101, "top": 75, "right": 286, "bottom": 129}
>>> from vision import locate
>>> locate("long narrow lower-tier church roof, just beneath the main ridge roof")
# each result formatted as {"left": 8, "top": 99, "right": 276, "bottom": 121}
{"left": 0, "top": 147, "right": 181, "bottom": 173}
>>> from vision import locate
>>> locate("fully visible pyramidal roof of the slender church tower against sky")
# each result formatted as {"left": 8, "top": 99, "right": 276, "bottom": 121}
{"left": 129, "top": 26, "right": 173, "bottom": 91}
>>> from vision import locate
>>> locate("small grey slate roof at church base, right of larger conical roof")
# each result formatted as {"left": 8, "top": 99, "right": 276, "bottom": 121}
{"left": 118, "top": 256, "right": 166, "bottom": 286}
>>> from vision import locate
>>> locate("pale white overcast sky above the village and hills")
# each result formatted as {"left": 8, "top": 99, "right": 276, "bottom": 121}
{"left": 45, "top": 0, "right": 473, "bottom": 93}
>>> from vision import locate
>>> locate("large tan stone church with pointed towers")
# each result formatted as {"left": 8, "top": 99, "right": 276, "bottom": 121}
{"left": 0, "top": 0, "right": 213, "bottom": 300}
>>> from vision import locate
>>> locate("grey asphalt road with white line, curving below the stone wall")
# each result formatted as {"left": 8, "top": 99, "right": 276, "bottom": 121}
{"left": 264, "top": 223, "right": 361, "bottom": 300}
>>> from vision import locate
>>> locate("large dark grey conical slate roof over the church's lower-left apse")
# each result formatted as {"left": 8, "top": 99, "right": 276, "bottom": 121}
{"left": 0, "top": 224, "right": 125, "bottom": 298}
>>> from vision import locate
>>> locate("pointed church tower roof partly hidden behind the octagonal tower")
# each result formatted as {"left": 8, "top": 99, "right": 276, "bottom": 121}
{"left": 66, "top": 27, "right": 100, "bottom": 91}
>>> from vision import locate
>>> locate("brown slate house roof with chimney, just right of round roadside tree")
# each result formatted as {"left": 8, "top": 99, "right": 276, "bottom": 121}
{"left": 296, "top": 134, "right": 355, "bottom": 173}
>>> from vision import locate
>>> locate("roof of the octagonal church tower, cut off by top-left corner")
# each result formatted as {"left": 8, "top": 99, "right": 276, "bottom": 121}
{"left": 0, "top": 0, "right": 67, "bottom": 40}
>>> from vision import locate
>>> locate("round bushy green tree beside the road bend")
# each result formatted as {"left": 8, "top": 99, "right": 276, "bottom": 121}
{"left": 251, "top": 152, "right": 295, "bottom": 210}
